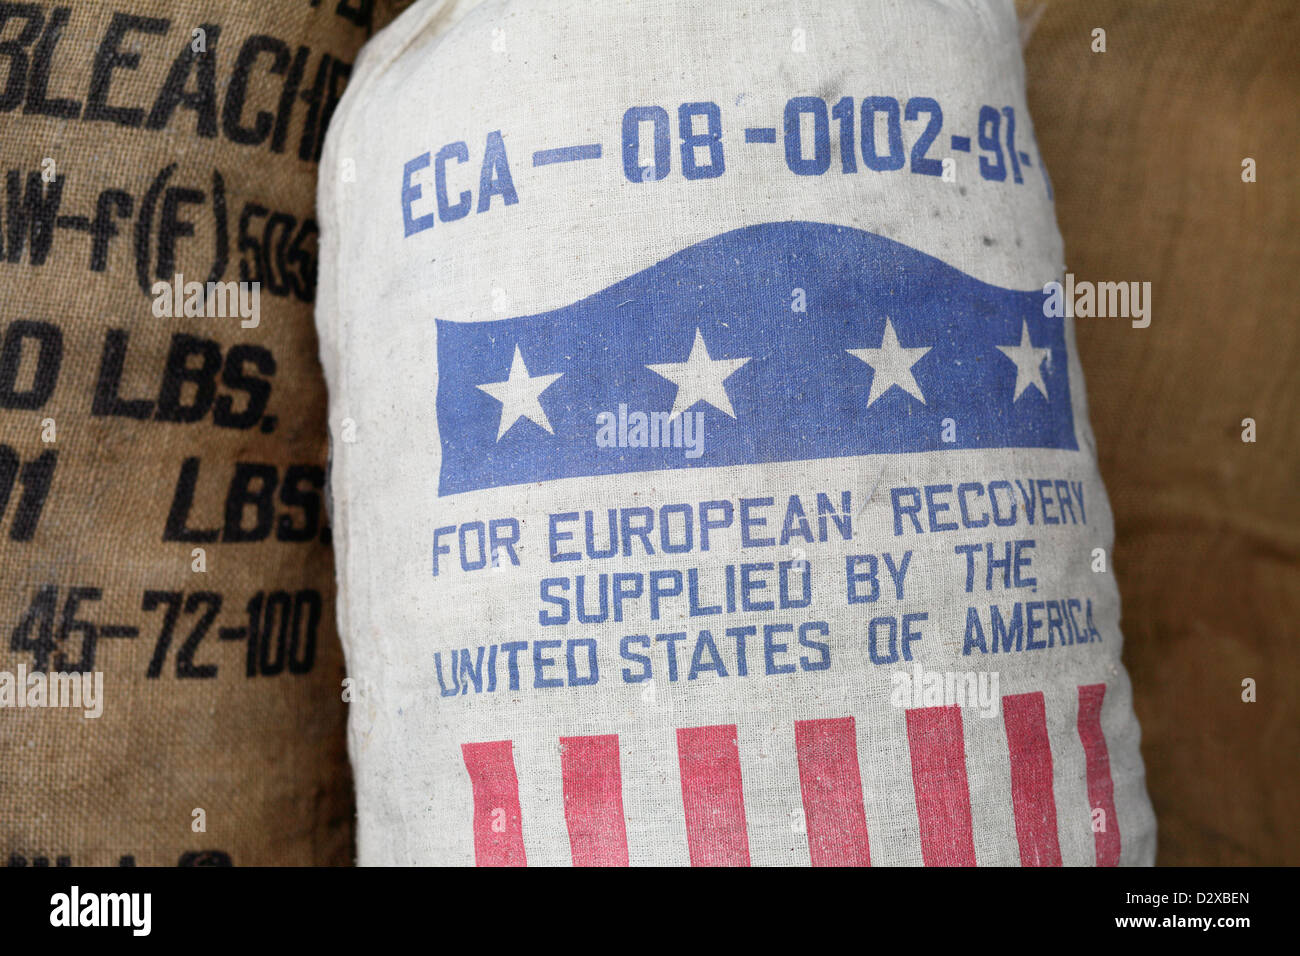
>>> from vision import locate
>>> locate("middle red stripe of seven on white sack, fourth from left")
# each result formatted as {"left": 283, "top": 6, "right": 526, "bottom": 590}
{"left": 794, "top": 717, "right": 871, "bottom": 866}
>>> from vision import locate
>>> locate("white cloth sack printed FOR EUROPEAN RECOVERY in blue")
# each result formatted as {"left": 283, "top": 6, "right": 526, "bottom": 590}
{"left": 317, "top": 0, "right": 1154, "bottom": 865}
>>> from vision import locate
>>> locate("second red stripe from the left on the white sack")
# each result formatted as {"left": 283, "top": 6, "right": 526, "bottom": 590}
{"left": 560, "top": 734, "right": 628, "bottom": 866}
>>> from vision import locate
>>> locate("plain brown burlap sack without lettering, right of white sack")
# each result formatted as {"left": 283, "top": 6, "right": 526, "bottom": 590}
{"left": 1022, "top": 0, "right": 1300, "bottom": 865}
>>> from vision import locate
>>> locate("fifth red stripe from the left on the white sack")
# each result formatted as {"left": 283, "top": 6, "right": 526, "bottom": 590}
{"left": 907, "top": 705, "right": 975, "bottom": 866}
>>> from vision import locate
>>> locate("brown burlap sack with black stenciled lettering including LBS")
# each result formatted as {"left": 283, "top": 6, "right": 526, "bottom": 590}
{"left": 0, "top": 0, "right": 400, "bottom": 865}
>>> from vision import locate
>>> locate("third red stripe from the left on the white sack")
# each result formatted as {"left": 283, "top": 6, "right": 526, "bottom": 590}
{"left": 677, "top": 723, "right": 749, "bottom": 866}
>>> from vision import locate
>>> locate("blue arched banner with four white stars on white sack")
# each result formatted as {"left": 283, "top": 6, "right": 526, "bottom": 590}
{"left": 437, "top": 221, "right": 1078, "bottom": 496}
